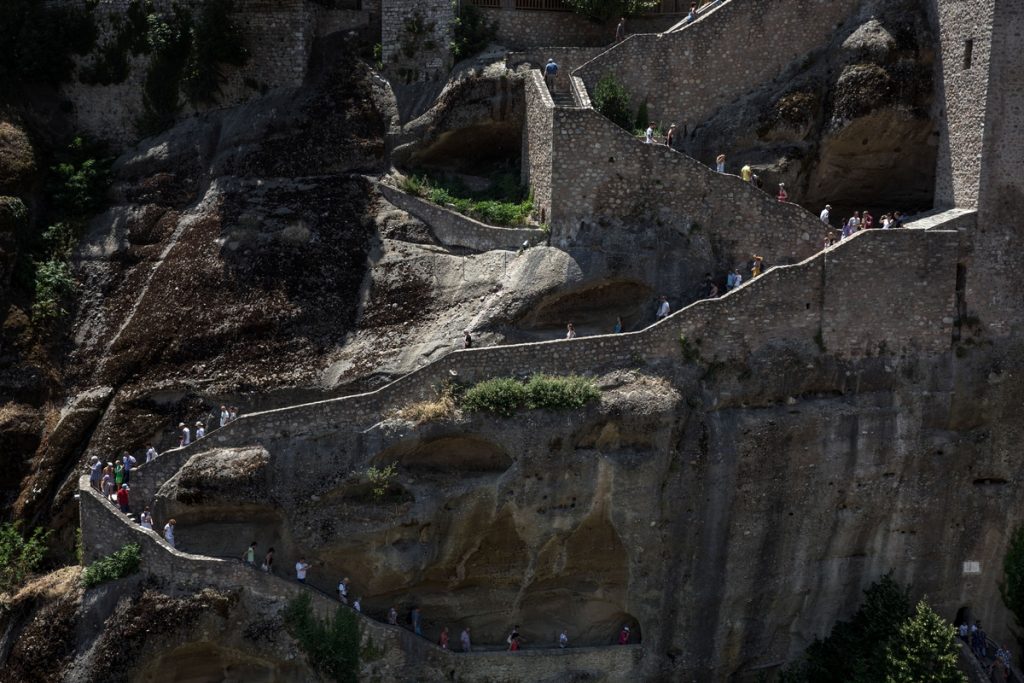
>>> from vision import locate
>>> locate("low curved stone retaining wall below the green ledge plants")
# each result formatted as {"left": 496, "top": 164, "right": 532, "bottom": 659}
{"left": 377, "top": 183, "right": 548, "bottom": 251}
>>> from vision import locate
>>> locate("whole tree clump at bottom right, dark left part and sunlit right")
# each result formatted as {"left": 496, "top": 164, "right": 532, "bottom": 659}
{"left": 779, "top": 574, "right": 966, "bottom": 683}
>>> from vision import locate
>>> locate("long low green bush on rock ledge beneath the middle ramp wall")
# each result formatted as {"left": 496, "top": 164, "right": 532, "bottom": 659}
{"left": 460, "top": 375, "right": 601, "bottom": 418}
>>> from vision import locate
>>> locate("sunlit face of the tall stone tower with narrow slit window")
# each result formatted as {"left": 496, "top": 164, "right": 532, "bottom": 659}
{"left": 930, "top": 0, "right": 991, "bottom": 207}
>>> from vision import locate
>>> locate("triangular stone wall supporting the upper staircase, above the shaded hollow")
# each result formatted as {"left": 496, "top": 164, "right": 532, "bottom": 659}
{"left": 544, "top": 104, "right": 822, "bottom": 264}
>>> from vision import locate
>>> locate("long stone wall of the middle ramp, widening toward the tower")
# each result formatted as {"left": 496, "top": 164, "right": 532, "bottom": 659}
{"left": 148, "top": 229, "right": 959, "bottom": 458}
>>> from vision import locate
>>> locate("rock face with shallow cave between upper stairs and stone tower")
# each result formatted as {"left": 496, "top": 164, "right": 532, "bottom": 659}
{"left": 683, "top": 0, "right": 938, "bottom": 220}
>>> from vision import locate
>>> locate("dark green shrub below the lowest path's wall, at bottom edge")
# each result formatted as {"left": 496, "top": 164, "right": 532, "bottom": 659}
{"left": 285, "top": 593, "right": 361, "bottom": 683}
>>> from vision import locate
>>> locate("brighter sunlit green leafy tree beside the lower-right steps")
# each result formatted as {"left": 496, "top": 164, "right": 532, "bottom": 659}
{"left": 879, "top": 600, "right": 967, "bottom": 683}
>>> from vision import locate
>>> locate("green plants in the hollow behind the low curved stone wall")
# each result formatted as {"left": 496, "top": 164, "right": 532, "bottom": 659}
{"left": 399, "top": 173, "right": 534, "bottom": 225}
